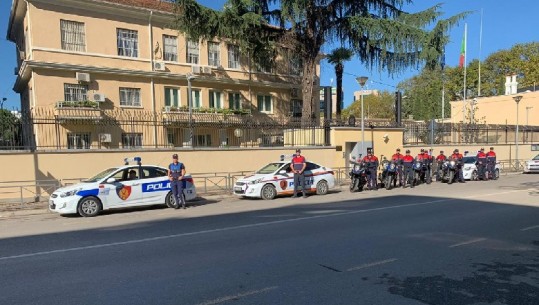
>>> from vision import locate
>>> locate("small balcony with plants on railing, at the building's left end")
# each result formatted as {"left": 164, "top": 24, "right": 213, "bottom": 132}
{"left": 54, "top": 101, "right": 103, "bottom": 121}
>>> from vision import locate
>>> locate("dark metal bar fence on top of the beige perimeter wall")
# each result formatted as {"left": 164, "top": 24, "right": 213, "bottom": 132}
{"left": 0, "top": 107, "right": 539, "bottom": 150}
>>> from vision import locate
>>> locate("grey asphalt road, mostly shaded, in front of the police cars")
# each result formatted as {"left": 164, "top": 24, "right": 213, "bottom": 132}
{"left": 0, "top": 175, "right": 539, "bottom": 305}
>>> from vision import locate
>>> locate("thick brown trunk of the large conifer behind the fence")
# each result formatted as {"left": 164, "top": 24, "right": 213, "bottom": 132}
{"left": 301, "top": 57, "right": 320, "bottom": 126}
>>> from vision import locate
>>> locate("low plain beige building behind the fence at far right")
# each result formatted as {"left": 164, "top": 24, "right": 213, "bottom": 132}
{"left": 450, "top": 91, "right": 539, "bottom": 126}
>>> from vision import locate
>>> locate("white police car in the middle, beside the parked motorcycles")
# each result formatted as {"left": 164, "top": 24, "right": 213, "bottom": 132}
{"left": 233, "top": 156, "right": 335, "bottom": 200}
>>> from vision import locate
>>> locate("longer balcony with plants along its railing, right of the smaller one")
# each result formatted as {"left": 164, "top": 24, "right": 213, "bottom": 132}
{"left": 162, "top": 106, "right": 251, "bottom": 124}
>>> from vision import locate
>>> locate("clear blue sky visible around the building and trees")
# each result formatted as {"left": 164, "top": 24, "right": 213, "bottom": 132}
{"left": 0, "top": 0, "right": 539, "bottom": 110}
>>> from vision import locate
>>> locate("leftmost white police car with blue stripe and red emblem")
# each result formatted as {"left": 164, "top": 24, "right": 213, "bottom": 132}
{"left": 49, "top": 157, "right": 196, "bottom": 217}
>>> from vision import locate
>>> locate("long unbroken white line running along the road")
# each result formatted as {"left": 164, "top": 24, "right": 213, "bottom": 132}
{"left": 0, "top": 190, "right": 518, "bottom": 261}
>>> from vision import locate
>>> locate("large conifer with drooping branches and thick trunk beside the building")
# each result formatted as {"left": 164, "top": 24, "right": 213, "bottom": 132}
{"left": 174, "top": 0, "right": 466, "bottom": 121}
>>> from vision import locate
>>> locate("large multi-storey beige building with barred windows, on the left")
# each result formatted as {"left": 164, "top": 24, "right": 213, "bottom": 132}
{"left": 7, "top": 0, "right": 319, "bottom": 149}
